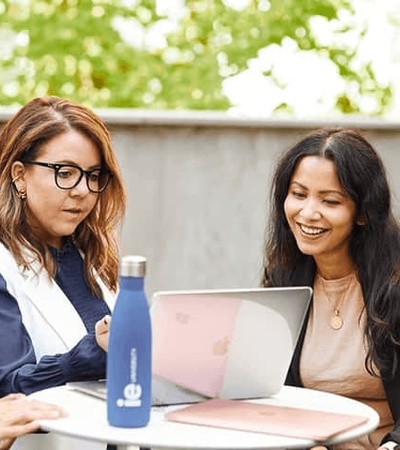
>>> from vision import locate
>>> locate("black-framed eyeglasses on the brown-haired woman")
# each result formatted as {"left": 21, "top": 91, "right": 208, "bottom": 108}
{"left": 22, "top": 161, "right": 112, "bottom": 194}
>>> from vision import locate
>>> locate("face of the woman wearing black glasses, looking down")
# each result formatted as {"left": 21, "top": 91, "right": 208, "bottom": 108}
{"left": 12, "top": 130, "right": 101, "bottom": 248}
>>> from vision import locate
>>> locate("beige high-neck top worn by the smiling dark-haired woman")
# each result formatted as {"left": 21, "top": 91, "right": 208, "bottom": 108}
{"left": 300, "top": 273, "right": 393, "bottom": 450}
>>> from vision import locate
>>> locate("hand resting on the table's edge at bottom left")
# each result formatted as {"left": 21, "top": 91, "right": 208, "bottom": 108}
{"left": 0, "top": 394, "right": 66, "bottom": 450}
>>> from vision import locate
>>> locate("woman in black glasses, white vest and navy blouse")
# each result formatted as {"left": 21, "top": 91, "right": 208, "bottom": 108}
{"left": 0, "top": 97, "right": 126, "bottom": 450}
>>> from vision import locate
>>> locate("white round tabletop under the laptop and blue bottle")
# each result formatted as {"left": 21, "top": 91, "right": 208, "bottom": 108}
{"left": 31, "top": 386, "right": 379, "bottom": 450}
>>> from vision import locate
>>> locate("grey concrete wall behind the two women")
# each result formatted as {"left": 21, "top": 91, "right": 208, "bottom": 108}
{"left": 0, "top": 109, "right": 400, "bottom": 294}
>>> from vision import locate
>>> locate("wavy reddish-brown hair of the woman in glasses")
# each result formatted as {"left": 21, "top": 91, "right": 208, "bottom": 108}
{"left": 0, "top": 97, "right": 126, "bottom": 298}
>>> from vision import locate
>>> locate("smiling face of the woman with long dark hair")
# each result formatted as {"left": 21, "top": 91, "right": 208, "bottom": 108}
{"left": 284, "top": 156, "right": 356, "bottom": 272}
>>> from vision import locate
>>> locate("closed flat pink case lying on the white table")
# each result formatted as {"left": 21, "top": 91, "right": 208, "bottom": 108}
{"left": 165, "top": 399, "right": 368, "bottom": 442}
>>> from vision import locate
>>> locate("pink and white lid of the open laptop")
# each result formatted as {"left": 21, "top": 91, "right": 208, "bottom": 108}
{"left": 150, "top": 287, "right": 312, "bottom": 399}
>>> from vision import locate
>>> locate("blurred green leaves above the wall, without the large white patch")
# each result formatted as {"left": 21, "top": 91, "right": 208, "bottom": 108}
{"left": 0, "top": 0, "right": 391, "bottom": 114}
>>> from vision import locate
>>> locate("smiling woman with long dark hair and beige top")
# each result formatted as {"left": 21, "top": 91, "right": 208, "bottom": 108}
{"left": 262, "top": 128, "right": 400, "bottom": 450}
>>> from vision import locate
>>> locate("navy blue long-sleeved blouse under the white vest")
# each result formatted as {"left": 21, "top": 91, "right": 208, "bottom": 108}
{"left": 0, "top": 245, "right": 110, "bottom": 396}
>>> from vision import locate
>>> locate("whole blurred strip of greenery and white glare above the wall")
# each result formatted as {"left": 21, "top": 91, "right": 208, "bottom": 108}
{"left": 0, "top": 0, "right": 400, "bottom": 118}
